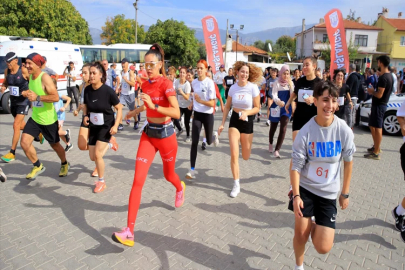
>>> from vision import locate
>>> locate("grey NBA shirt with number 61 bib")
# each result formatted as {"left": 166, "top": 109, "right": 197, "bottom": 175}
{"left": 292, "top": 116, "right": 356, "bottom": 200}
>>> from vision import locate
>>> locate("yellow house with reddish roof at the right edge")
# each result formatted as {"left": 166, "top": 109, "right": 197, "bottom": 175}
{"left": 376, "top": 9, "right": 405, "bottom": 71}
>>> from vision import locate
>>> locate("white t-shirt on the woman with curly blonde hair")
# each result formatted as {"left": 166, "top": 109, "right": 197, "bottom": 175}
{"left": 228, "top": 82, "right": 260, "bottom": 110}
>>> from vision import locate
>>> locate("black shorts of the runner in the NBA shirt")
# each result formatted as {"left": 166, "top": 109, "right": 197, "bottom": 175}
{"left": 288, "top": 186, "right": 337, "bottom": 229}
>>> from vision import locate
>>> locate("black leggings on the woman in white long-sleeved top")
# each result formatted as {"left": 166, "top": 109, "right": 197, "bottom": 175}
{"left": 190, "top": 111, "right": 214, "bottom": 168}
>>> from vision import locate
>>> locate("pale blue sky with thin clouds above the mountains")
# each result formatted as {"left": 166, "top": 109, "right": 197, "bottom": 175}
{"left": 71, "top": 0, "right": 405, "bottom": 33}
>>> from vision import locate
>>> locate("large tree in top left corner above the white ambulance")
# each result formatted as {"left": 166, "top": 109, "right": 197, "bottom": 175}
{"left": 0, "top": 0, "right": 92, "bottom": 44}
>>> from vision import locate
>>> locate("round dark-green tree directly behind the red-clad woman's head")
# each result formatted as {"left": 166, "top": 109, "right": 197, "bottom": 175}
{"left": 145, "top": 19, "right": 199, "bottom": 66}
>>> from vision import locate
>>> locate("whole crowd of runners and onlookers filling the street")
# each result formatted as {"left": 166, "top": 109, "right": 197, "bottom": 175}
{"left": 0, "top": 44, "right": 405, "bottom": 269}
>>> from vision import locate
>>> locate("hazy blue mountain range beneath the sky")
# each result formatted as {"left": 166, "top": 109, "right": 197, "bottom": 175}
{"left": 90, "top": 24, "right": 314, "bottom": 45}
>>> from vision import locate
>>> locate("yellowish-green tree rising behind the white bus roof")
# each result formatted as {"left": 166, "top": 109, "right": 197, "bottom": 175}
{"left": 100, "top": 14, "right": 146, "bottom": 45}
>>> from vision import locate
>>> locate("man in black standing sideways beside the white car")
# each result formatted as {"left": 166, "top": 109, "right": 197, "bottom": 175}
{"left": 364, "top": 55, "right": 393, "bottom": 160}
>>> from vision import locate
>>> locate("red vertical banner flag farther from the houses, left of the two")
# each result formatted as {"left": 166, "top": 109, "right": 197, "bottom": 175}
{"left": 201, "top": 15, "right": 224, "bottom": 74}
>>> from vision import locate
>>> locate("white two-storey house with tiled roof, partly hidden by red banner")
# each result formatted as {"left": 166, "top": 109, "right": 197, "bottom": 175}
{"left": 295, "top": 18, "right": 387, "bottom": 70}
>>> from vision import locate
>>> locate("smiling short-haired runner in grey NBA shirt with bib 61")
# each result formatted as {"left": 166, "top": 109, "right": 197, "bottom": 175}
{"left": 288, "top": 80, "right": 356, "bottom": 270}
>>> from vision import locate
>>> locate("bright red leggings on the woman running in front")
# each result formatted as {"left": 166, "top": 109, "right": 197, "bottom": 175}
{"left": 127, "top": 132, "right": 183, "bottom": 232}
